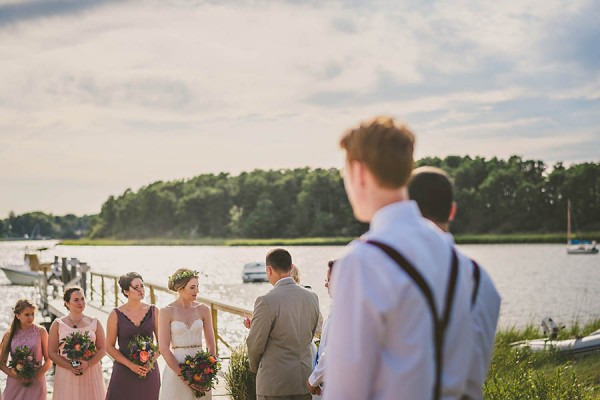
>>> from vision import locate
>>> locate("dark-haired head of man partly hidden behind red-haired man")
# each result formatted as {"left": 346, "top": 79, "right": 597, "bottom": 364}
{"left": 408, "top": 167, "right": 456, "bottom": 231}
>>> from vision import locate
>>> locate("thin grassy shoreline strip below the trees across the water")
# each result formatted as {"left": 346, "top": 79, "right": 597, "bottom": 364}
{"left": 44, "top": 232, "right": 600, "bottom": 246}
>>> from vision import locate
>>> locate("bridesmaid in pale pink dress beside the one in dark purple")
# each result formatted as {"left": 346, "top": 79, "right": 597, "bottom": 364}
{"left": 48, "top": 286, "right": 106, "bottom": 400}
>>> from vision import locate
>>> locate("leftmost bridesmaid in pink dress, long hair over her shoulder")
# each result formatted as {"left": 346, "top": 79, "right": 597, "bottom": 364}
{"left": 0, "top": 299, "right": 52, "bottom": 400}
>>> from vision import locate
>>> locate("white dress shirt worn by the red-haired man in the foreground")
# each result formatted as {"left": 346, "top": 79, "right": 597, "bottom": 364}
{"left": 324, "top": 201, "right": 473, "bottom": 400}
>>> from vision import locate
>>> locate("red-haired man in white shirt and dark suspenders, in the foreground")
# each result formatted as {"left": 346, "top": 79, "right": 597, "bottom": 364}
{"left": 324, "top": 117, "right": 473, "bottom": 400}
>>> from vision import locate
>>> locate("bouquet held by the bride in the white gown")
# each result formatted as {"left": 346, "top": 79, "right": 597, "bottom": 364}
{"left": 180, "top": 351, "right": 221, "bottom": 397}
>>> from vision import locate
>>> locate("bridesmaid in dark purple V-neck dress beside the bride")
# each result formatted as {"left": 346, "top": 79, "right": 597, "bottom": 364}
{"left": 106, "top": 272, "right": 160, "bottom": 400}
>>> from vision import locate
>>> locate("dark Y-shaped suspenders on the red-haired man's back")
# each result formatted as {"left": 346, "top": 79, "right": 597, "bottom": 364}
{"left": 366, "top": 240, "right": 458, "bottom": 400}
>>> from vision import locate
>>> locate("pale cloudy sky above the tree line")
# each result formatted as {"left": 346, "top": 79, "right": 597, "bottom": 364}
{"left": 0, "top": 0, "right": 600, "bottom": 218}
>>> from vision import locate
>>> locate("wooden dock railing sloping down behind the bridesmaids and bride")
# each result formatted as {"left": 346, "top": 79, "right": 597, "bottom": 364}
{"left": 86, "top": 272, "right": 252, "bottom": 354}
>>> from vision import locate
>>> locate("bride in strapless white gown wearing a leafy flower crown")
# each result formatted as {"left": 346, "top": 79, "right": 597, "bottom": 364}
{"left": 158, "top": 268, "right": 216, "bottom": 400}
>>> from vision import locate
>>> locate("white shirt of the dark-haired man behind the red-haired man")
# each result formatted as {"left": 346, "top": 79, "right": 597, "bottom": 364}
{"left": 447, "top": 233, "right": 501, "bottom": 399}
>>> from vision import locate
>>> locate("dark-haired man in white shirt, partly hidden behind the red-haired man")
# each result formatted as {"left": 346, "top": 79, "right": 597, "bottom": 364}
{"left": 408, "top": 167, "right": 501, "bottom": 399}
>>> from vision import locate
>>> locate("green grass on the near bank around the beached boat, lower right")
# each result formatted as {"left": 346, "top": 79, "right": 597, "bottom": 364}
{"left": 484, "top": 320, "right": 600, "bottom": 400}
